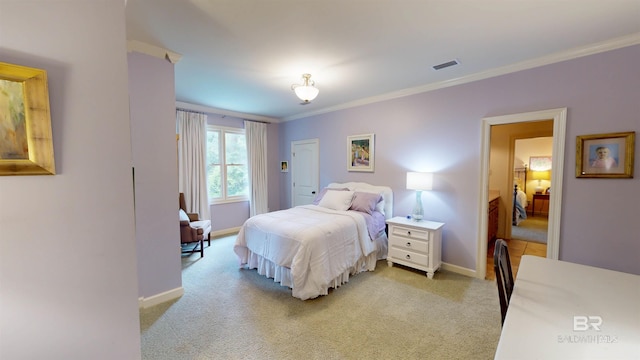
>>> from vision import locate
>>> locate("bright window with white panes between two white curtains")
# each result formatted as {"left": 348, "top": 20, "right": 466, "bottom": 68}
{"left": 207, "top": 125, "right": 249, "bottom": 203}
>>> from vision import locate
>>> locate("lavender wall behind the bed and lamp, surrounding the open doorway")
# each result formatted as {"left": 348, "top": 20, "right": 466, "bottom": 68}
{"left": 278, "top": 45, "right": 640, "bottom": 274}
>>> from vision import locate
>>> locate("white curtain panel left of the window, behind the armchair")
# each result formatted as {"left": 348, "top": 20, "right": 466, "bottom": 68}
{"left": 176, "top": 110, "right": 211, "bottom": 220}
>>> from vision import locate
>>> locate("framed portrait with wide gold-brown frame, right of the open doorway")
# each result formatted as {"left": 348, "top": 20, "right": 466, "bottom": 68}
{"left": 576, "top": 131, "right": 636, "bottom": 178}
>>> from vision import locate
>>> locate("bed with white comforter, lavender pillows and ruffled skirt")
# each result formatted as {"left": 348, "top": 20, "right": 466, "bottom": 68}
{"left": 234, "top": 182, "right": 393, "bottom": 300}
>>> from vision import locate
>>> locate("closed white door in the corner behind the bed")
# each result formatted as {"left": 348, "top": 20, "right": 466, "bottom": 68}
{"left": 289, "top": 139, "right": 320, "bottom": 207}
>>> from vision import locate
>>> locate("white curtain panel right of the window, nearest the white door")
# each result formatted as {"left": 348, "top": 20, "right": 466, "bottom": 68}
{"left": 244, "top": 121, "right": 269, "bottom": 216}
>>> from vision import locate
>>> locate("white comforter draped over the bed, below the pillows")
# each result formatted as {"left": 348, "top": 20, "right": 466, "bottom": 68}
{"left": 234, "top": 205, "right": 376, "bottom": 300}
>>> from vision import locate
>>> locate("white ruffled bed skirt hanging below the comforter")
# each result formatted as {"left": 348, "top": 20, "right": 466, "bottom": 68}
{"left": 241, "top": 232, "right": 388, "bottom": 298}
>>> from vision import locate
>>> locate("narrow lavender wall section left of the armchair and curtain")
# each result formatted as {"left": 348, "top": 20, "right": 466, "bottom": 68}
{"left": 128, "top": 52, "right": 182, "bottom": 298}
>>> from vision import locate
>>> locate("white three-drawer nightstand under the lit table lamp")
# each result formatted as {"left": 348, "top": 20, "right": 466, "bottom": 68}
{"left": 387, "top": 216, "right": 444, "bottom": 279}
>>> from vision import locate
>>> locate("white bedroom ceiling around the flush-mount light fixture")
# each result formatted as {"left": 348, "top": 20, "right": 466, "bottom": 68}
{"left": 126, "top": 0, "right": 640, "bottom": 120}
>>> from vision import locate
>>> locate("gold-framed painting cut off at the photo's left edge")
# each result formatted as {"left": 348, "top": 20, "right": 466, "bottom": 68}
{"left": 0, "top": 62, "right": 56, "bottom": 175}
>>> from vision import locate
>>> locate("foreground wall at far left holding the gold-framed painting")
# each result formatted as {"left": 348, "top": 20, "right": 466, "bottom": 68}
{"left": 0, "top": 0, "right": 141, "bottom": 360}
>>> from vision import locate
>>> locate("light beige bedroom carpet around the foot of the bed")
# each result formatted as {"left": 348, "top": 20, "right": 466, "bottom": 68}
{"left": 140, "top": 236, "right": 501, "bottom": 360}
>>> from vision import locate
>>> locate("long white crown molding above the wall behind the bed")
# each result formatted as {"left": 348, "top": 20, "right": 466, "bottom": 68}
{"left": 282, "top": 32, "right": 640, "bottom": 121}
